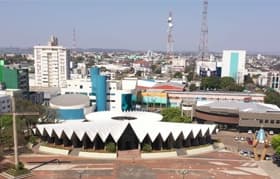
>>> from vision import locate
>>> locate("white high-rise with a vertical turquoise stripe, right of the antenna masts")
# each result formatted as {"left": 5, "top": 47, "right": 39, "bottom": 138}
{"left": 222, "top": 50, "right": 246, "bottom": 84}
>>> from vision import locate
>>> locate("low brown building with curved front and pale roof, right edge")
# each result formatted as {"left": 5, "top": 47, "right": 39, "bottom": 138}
{"left": 194, "top": 100, "right": 280, "bottom": 132}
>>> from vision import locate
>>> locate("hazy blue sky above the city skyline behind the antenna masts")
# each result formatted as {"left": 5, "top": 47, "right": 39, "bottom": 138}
{"left": 0, "top": 0, "right": 280, "bottom": 53}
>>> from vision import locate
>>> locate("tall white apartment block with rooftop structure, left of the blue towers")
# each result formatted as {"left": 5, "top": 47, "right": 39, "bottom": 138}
{"left": 34, "top": 36, "right": 70, "bottom": 87}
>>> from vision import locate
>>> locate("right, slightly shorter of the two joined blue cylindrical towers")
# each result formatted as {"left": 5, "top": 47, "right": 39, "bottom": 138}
{"left": 95, "top": 75, "right": 107, "bottom": 111}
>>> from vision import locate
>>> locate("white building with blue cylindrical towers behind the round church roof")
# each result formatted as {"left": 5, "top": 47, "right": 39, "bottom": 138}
{"left": 61, "top": 67, "right": 132, "bottom": 111}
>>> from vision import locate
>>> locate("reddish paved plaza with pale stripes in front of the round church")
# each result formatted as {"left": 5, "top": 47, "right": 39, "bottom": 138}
{"left": 0, "top": 151, "right": 270, "bottom": 179}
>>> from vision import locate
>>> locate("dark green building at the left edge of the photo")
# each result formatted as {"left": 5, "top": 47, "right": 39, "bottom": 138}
{"left": 0, "top": 60, "right": 29, "bottom": 97}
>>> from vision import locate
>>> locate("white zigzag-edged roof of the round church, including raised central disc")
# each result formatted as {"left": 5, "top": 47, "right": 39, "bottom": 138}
{"left": 37, "top": 111, "right": 216, "bottom": 145}
